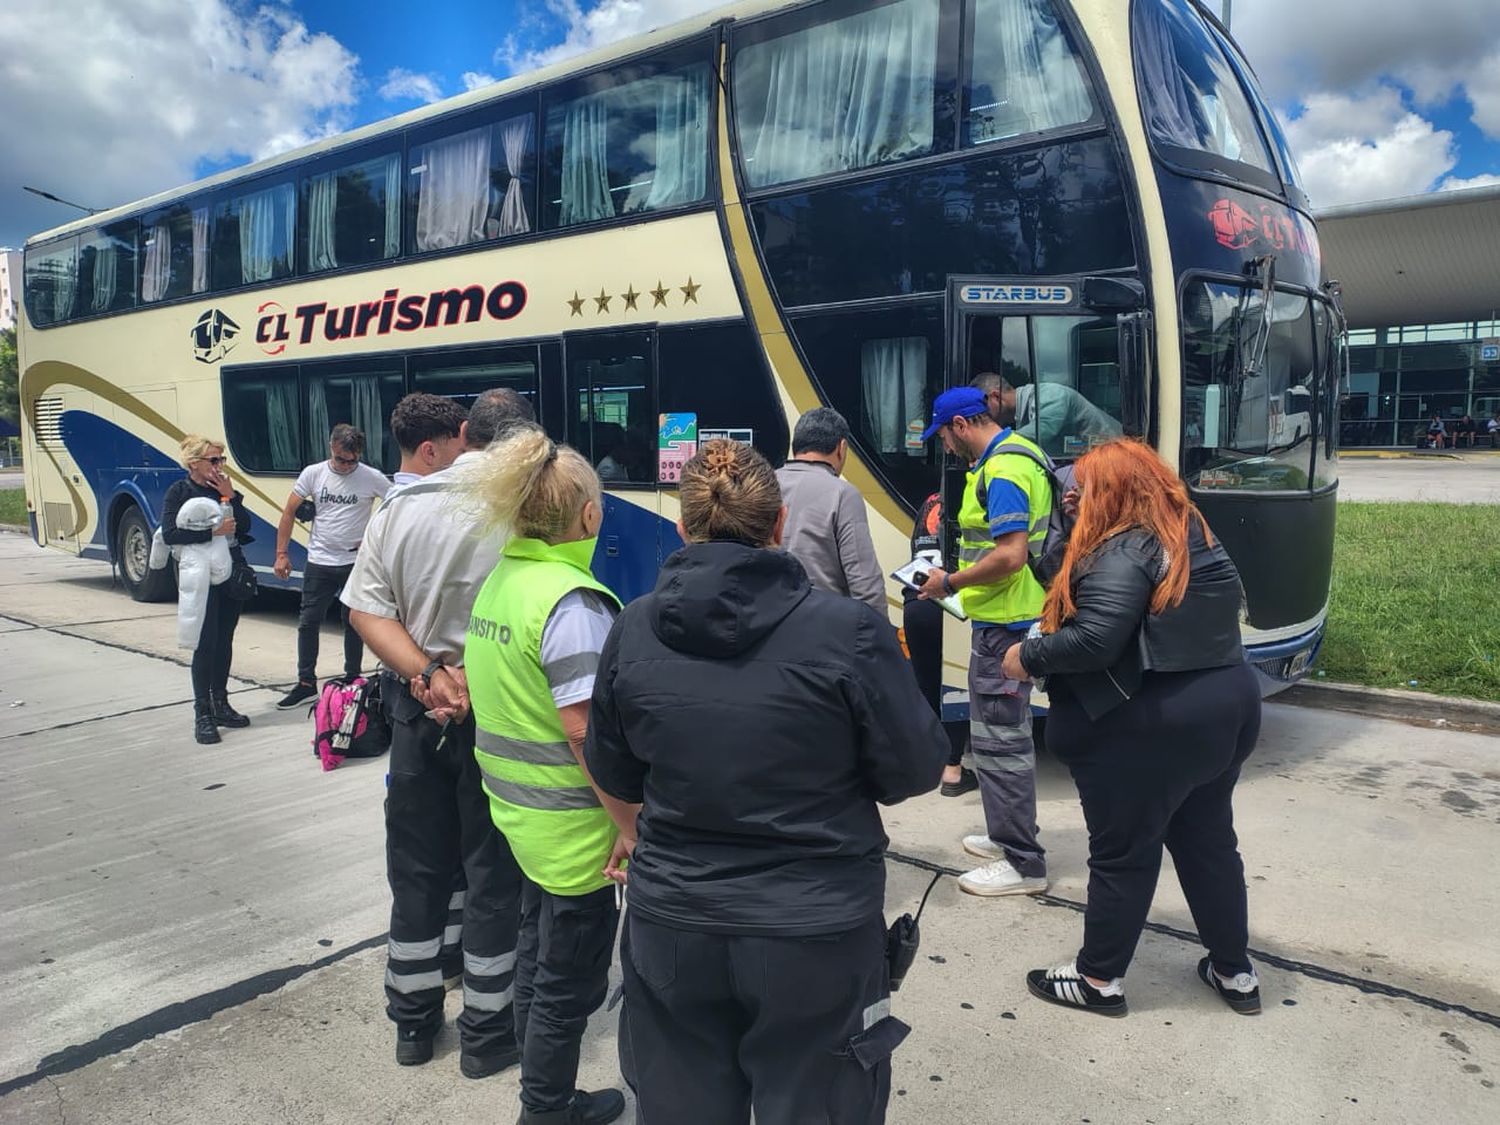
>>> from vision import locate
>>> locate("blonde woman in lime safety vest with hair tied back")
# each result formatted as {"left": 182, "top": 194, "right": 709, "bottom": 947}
{"left": 464, "top": 428, "right": 639, "bottom": 1125}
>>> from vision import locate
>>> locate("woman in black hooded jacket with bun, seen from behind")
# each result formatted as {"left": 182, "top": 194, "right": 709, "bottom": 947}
{"left": 585, "top": 441, "right": 948, "bottom": 1125}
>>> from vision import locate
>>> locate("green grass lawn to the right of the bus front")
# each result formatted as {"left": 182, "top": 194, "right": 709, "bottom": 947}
{"left": 1319, "top": 504, "right": 1500, "bottom": 702}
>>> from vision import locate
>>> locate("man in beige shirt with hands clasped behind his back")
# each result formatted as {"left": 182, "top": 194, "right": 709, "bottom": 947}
{"left": 342, "top": 389, "right": 533, "bottom": 1079}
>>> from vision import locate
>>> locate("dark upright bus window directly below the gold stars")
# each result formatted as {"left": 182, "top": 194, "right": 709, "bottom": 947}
{"left": 564, "top": 332, "right": 657, "bottom": 486}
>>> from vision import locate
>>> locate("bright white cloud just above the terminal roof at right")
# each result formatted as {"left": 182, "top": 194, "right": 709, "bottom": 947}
{"left": 1287, "top": 86, "right": 1458, "bottom": 207}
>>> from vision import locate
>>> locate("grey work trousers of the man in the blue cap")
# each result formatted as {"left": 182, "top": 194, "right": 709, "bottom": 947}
{"left": 969, "top": 626, "right": 1047, "bottom": 879}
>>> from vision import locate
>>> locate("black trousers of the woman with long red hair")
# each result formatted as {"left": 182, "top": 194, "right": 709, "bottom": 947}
{"left": 1047, "top": 665, "right": 1260, "bottom": 980}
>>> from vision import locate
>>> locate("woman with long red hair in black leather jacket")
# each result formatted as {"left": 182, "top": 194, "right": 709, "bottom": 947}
{"left": 1004, "top": 441, "right": 1260, "bottom": 1016}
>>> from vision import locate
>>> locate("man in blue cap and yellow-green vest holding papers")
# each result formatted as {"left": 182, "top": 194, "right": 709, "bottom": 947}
{"left": 921, "top": 387, "right": 1052, "bottom": 896}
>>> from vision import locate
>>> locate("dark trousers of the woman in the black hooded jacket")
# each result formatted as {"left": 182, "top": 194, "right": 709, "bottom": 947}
{"left": 620, "top": 912, "right": 908, "bottom": 1125}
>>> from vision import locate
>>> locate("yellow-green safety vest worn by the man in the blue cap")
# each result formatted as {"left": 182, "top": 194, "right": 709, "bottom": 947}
{"left": 959, "top": 431, "right": 1052, "bottom": 626}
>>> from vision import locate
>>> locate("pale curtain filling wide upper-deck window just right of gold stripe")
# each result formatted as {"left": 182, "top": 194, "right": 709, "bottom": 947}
{"left": 735, "top": 0, "right": 941, "bottom": 188}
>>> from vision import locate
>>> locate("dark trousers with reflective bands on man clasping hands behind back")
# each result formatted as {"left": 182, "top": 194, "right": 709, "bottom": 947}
{"left": 381, "top": 675, "right": 522, "bottom": 1056}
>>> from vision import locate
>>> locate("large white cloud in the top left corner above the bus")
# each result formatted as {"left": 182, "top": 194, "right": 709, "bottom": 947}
{"left": 0, "top": 0, "right": 359, "bottom": 243}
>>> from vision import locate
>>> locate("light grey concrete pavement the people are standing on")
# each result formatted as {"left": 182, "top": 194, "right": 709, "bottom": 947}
{"left": 0, "top": 536, "right": 1500, "bottom": 1125}
